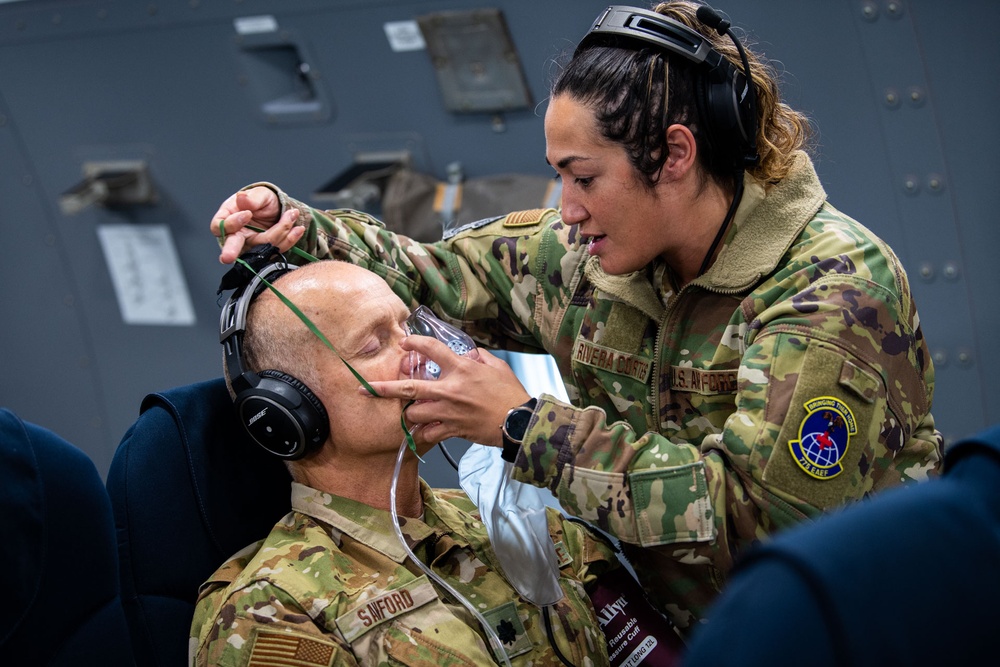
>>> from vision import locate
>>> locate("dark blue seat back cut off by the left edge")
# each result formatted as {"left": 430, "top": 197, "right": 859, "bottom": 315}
{"left": 0, "top": 409, "right": 132, "bottom": 666}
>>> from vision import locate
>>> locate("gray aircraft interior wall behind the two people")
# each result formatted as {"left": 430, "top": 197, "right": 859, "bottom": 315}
{"left": 0, "top": 0, "right": 1000, "bottom": 482}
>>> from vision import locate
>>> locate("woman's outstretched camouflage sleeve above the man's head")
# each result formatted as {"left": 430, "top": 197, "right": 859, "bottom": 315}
{"left": 247, "top": 183, "right": 582, "bottom": 352}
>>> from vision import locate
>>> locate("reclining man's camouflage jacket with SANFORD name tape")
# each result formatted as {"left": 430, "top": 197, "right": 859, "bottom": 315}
{"left": 191, "top": 482, "right": 618, "bottom": 667}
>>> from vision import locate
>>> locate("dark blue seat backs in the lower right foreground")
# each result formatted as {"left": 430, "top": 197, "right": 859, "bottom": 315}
{"left": 685, "top": 427, "right": 1000, "bottom": 667}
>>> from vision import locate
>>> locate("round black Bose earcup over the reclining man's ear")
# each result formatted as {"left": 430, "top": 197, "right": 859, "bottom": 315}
{"left": 236, "top": 370, "right": 330, "bottom": 460}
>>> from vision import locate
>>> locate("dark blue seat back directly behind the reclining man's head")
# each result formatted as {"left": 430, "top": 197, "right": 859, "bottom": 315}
{"left": 107, "top": 378, "right": 291, "bottom": 667}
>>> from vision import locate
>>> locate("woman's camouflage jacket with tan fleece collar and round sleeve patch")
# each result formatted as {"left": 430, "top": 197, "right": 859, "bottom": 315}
{"left": 254, "top": 153, "right": 942, "bottom": 628}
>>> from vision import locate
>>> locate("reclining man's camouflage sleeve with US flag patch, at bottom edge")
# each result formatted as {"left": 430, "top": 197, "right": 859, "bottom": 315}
{"left": 191, "top": 582, "right": 358, "bottom": 667}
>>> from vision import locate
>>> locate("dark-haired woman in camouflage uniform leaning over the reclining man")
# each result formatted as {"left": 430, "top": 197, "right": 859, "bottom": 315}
{"left": 212, "top": 2, "right": 942, "bottom": 628}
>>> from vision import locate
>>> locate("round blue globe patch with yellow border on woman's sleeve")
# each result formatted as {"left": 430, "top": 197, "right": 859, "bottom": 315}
{"left": 788, "top": 396, "right": 858, "bottom": 479}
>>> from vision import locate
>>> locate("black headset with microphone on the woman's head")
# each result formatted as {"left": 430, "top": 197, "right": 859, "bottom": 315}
{"left": 576, "top": 5, "right": 760, "bottom": 171}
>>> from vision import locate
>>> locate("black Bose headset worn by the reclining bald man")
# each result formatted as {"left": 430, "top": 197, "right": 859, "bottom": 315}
{"left": 219, "top": 246, "right": 330, "bottom": 460}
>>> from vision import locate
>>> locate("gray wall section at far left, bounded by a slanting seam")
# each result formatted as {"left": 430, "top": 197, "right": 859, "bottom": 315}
{"left": 0, "top": 86, "right": 111, "bottom": 465}
